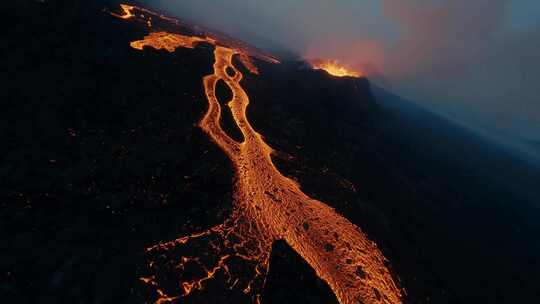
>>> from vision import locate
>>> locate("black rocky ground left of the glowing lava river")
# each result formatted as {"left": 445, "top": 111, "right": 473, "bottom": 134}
{"left": 0, "top": 1, "right": 232, "bottom": 303}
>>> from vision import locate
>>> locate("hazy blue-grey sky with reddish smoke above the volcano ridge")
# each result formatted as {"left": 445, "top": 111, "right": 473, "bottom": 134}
{"left": 157, "top": 0, "right": 540, "bottom": 140}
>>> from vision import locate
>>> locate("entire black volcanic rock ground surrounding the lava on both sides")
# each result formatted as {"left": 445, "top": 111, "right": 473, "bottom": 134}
{"left": 4, "top": 0, "right": 540, "bottom": 304}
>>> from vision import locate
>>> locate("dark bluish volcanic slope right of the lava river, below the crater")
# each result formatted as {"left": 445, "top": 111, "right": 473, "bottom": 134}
{"left": 245, "top": 58, "right": 540, "bottom": 303}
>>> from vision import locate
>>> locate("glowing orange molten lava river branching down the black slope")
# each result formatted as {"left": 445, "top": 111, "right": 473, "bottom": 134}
{"left": 113, "top": 6, "right": 402, "bottom": 304}
